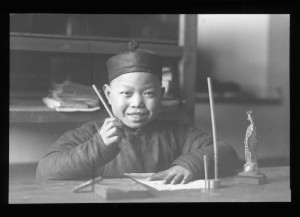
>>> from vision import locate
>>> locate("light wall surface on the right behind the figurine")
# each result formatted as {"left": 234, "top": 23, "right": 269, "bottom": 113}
{"left": 195, "top": 14, "right": 290, "bottom": 163}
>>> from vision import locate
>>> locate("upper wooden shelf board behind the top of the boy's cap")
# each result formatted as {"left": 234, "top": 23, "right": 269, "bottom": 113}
{"left": 10, "top": 33, "right": 183, "bottom": 58}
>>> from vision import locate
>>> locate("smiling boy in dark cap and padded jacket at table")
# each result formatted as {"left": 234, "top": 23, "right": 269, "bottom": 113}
{"left": 36, "top": 40, "right": 238, "bottom": 184}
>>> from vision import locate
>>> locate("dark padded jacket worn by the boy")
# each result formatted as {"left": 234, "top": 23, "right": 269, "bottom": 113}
{"left": 36, "top": 120, "right": 238, "bottom": 179}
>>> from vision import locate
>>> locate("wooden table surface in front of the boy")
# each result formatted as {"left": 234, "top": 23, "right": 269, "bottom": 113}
{"left": 9, "top": 167, "right": 291, "bottom": 204}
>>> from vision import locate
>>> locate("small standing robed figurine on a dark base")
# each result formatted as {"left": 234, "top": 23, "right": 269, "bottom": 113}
{"left": 237, "top": 110, "right": 266, "bottom": 184}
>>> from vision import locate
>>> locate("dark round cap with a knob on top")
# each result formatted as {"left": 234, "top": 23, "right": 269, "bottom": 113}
{"left": 106, "top": 41, "right": 162, "bottom": 82}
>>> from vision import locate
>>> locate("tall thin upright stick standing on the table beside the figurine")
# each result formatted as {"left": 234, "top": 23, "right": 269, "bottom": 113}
{"left": 207, "top": 77, "right": 218, "bottom": 179}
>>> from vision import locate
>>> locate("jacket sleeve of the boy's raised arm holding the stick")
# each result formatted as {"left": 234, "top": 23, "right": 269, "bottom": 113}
{"left": 36, "top": 122, "right": 119, "bottom": 179}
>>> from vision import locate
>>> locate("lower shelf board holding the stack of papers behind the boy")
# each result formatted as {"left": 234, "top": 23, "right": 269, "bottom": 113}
{"left": 9, "top": 100, "right": 183, "bottom": 123}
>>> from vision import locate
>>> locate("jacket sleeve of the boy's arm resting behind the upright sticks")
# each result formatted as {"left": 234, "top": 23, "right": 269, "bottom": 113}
{"left": 172, "top": 125, "right": 239, "bottom": 179}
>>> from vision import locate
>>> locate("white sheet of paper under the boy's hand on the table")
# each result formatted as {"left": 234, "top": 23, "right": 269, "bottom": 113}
{"left": 124, "top": 173, "right": 205, "bottom": 191}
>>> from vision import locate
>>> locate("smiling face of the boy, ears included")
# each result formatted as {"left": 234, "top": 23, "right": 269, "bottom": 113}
{"left": 103, "top": 72, "right": 164, "bottom": 128}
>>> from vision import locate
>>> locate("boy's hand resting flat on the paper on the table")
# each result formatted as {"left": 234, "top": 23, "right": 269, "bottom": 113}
{"left": 148, "top": 165, "right": 193, "bottom": 184}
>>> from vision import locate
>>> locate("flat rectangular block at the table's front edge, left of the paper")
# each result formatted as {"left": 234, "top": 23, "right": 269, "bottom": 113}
{"left": 94, "top": 178, "right": 151, "bottom": 200}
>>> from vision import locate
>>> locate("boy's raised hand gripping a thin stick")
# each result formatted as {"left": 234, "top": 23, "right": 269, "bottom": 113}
{"left": 99, "top": 118, "right": 123, "bottom": 146}
